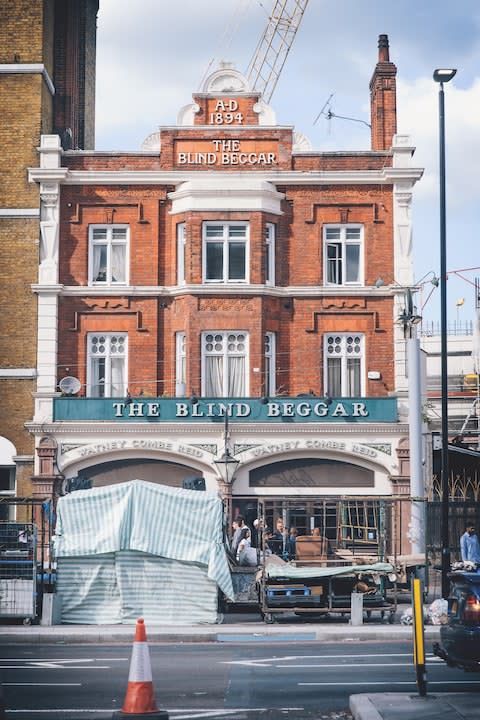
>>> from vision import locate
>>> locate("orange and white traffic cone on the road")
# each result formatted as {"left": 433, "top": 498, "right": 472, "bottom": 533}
{"left": 112, "top": 618, "right": 168, "bottom": 720}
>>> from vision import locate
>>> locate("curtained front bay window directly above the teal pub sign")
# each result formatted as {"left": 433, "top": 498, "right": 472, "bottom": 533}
{"left": 202, "top": 331, "right": 248, "bottom": 397}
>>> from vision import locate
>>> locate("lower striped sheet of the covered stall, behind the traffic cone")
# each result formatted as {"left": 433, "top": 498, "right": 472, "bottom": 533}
{"left": 57, "top": 550, "right": 218, "bottom": 625}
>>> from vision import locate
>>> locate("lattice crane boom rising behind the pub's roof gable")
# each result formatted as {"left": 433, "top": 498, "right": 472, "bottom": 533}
{"left": 246, "top": 0, "right": 308, "bottom": 103}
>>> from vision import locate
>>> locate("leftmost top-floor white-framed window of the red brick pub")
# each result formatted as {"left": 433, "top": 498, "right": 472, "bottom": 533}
{"left": 88, "top": 225, "right": 129, "bottom": 285}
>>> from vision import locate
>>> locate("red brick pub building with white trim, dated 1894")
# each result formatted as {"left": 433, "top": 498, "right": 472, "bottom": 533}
{"left": 29, "top": 35, "right": 422, "bottom": 556}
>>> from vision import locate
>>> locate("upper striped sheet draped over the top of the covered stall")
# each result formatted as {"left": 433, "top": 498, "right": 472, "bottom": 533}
{"left": 54, "top": 480, "right": 233, "bottom": 600}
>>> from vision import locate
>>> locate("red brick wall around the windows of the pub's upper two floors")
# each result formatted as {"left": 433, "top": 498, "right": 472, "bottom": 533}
{"left": 54, "top": 169, "right": 394, "bottom": 396}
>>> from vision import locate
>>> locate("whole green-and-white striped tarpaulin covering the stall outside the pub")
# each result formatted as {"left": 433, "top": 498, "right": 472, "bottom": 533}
{"left": 54, "top": 480, "right": 233, "bottom": 624}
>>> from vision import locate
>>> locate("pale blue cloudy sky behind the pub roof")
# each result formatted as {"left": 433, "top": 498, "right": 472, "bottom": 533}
{"left": 96, "top": 0, "right": 480, "bottom": 325}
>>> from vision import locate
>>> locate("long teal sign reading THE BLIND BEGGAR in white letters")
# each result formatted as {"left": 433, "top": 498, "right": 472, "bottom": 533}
{"left": 53, "top": 397, "right": 398, "bottom": 424}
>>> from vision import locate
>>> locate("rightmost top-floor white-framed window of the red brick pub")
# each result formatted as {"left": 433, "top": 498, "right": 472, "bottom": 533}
{"left": 323, "top": 225, "right": 363, "bottom": 285}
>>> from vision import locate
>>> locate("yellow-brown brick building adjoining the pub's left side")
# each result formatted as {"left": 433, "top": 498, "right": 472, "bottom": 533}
{"left": 0, "top": 0, "right": 98, "bottom": 520}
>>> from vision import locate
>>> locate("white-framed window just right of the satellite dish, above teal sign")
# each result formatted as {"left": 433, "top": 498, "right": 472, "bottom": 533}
{"left": 87, "top": 333, "right": 128, "bottom": 397}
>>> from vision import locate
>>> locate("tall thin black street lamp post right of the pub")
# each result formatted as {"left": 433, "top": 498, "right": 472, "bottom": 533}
{"left": 433, "top": 68, "right": 457, "bottom": 598}
